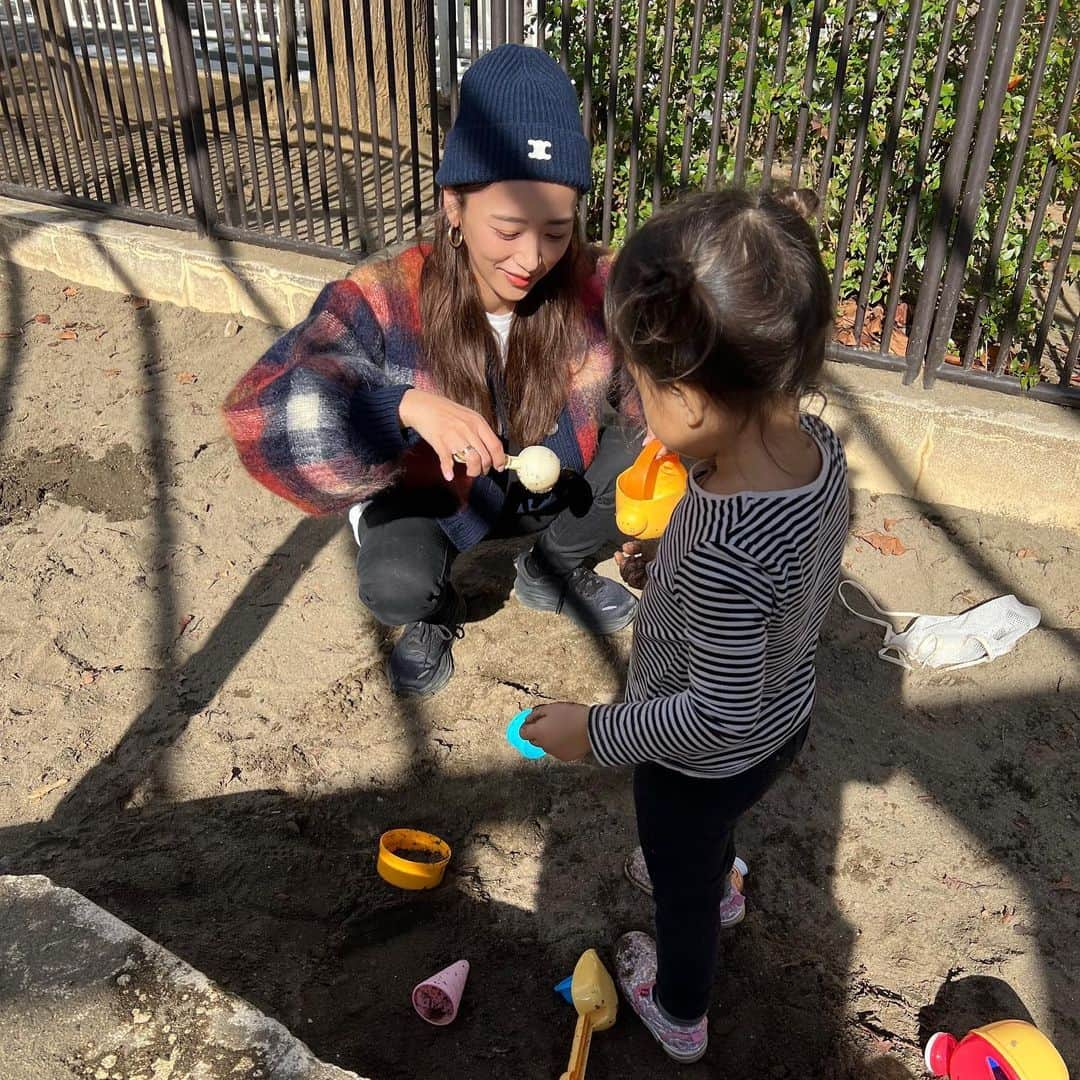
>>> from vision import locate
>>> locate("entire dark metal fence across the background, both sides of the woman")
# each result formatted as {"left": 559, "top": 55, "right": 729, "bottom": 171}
{"left": 0, "top": 0, "right": 1080, "bottom": 405}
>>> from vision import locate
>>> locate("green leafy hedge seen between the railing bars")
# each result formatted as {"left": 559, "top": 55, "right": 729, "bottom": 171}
{"left": 544, "top": 0, "right": 1080, "bottom": 382}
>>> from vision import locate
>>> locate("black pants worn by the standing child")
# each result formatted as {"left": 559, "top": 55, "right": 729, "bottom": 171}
{"left": 634, "top": 724, "right": 810, "bottom": 1023}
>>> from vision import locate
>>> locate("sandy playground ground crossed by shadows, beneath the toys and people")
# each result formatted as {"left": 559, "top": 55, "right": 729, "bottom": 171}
{"left": 0, "top": 267, "right": 1080, "bottom": 1080}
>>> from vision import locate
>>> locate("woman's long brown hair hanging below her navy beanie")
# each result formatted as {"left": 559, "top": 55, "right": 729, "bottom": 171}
{"left": 420, "top": 188, "right": 591, "bottom": 446}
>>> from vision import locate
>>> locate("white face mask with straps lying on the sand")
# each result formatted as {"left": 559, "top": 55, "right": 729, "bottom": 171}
{"left": 839, "top": 581, "right": 1042, "bottom": 669}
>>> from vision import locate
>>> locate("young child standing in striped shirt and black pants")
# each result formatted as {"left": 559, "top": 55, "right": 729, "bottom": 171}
{"left": 522, "top": 190, "right": 848, "bottom": 1062}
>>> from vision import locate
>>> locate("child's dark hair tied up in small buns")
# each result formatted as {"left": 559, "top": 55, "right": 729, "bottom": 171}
{"left": 606, "top": 188, "right": 833, "bottom": 419}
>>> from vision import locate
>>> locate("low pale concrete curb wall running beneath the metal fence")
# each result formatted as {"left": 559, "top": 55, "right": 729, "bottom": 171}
{"left": 0, "top": 199, "right": 1080, "bottom": 529}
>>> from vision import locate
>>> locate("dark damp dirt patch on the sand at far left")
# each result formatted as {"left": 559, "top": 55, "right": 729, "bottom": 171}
{"left": 0, "top": 444, "right": 150, "bottom": 526}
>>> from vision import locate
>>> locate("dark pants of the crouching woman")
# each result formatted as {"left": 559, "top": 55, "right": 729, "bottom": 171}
{"left": 356, "top": 426, "right": 642, "bottom": 626}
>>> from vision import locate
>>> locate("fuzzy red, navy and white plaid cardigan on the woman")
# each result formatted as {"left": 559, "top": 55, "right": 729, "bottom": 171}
{"left": 224, "top": 246, "right": 621, "bottom": 551}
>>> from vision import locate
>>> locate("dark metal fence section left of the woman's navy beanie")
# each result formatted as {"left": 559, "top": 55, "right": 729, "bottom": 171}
{"left": 0, "top": 0, "right": 447, "bottom": 252}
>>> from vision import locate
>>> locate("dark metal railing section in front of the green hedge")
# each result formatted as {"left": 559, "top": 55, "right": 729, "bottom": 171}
{"left": 540, "top": 0, "right": 1080, "bottom": 405}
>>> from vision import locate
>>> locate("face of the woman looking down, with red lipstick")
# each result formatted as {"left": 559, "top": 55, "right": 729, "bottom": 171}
{"left": 443, "top": 180, "right": 578, "bottom": 315}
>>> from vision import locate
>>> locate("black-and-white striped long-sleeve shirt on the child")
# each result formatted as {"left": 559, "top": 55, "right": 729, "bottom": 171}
{"left": 589, "top": 416, "right": 848, "bottom": 777}
